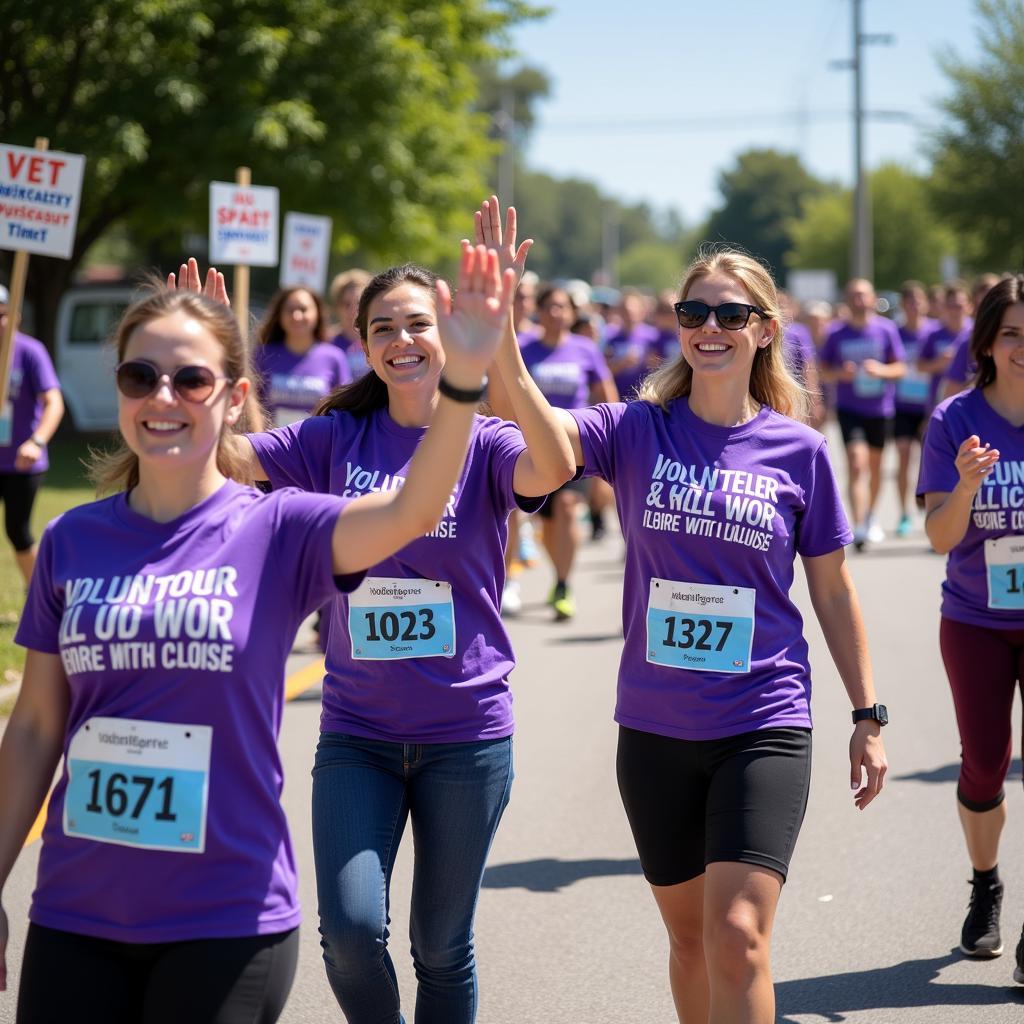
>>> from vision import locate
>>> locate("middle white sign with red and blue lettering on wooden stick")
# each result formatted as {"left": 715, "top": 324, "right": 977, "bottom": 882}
{"left": 210, "top": 181, "right": 278, "bottom": 266}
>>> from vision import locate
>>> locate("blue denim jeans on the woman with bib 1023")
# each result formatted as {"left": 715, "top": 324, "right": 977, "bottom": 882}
{"left": 312, "top": 732, "right": 512, "bottom": 1024}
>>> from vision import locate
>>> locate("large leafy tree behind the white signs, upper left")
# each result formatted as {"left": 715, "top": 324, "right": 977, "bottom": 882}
{"left": 0, "top": 0, "right": 535, "bottom": 346}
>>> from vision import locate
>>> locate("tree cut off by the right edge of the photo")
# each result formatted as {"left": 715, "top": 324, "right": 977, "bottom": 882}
{"left": 930, "top": 0, "right": 1024, "bottom": 269}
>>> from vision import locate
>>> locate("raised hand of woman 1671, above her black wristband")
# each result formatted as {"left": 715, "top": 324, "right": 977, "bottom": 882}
{"left": 437, "top": 242, "right": 515, "bottom": 390}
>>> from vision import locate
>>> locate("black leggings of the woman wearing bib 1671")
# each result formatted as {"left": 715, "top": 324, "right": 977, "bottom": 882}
{"left": 16, "top": 925, "right": 299, "bottom": 1024}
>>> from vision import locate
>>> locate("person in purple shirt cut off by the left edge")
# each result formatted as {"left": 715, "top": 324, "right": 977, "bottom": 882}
{"left": 0, "top": 285, "right": 65, "bottom": 587}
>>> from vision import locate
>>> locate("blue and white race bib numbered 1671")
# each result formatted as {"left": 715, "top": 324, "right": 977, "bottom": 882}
{"left": 63, "top": 718, "right": 213, "bottom": 853}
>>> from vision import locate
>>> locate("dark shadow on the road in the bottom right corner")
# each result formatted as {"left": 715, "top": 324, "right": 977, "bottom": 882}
{"left": 775, "top": 950, "right": 1024, "bottom": 1024}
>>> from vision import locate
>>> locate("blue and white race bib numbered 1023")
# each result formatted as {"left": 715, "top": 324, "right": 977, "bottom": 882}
{"left": 348, "top": 577, "right": 455, "bottom": 662}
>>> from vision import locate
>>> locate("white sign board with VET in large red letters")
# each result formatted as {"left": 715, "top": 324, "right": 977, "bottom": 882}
{"left": 0, "top": 144, "right": 85, "bottom": 259}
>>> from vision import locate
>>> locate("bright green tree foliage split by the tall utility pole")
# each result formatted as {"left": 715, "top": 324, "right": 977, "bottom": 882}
{"left": 787, "top": 164, "right": 956, "bottom": 291}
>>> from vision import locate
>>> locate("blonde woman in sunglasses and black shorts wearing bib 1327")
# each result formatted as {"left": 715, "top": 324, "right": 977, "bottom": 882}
{"left": 492, "top": 243, "right": 886, "bottom": 1024}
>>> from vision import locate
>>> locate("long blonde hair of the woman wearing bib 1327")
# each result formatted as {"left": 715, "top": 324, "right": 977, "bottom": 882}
{"left": 639, "top": 246, "right": 810, "bottom": 420}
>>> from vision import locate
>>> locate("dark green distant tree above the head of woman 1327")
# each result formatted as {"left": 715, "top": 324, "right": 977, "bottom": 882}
{"left": 703, "top": 150, "right": 825, "bottom": 276}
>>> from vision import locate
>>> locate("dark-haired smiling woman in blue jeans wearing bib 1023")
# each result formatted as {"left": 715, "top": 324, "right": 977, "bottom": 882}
{"left": 227, "top": 197, "right": 574, "bottom": 1024}
